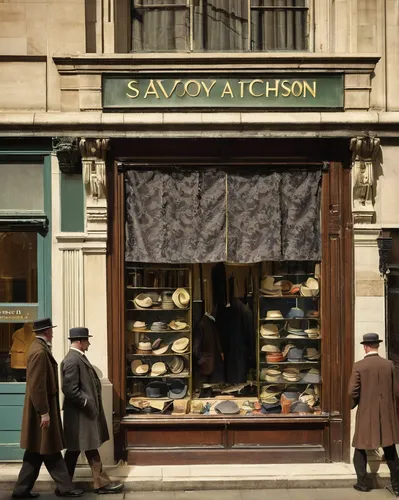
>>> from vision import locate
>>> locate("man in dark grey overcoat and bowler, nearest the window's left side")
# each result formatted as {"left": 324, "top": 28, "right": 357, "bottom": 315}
{"left": 61, "top": 328, "right": 123, "bottom": 494}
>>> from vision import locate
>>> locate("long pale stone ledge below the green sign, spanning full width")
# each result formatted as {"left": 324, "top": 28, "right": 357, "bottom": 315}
{"left": 0, "top": 111, "right": 399, "bottom": 138}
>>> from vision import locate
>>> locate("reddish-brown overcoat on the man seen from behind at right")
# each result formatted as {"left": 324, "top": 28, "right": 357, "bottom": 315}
{"left": 349, "top": 353, "right": 399, "bottom": 450}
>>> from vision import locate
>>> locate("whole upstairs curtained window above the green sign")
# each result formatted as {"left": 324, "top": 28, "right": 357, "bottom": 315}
{"left": 132, "top": 0, "right": 309, "bottom": 52}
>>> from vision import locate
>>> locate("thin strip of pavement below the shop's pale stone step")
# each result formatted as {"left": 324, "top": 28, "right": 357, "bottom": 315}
{"left": 0, "top": 488, "right": 395, "bottom": 500}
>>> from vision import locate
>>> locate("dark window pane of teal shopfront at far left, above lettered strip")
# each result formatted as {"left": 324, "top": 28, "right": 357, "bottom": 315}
{"left": 0, "top": 232, "right": 37, "bottom": 303}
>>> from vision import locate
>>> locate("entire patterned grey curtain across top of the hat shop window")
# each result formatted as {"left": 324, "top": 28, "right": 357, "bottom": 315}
{"left": 125, "top": 169, "right": 321, "bottom": 264}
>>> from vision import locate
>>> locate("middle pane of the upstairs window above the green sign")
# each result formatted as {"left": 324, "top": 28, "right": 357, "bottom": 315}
{"left": 194, "top": 0, "right": 249, "bottom": 51}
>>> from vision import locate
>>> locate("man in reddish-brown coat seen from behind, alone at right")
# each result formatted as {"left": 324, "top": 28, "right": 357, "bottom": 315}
{"left": 349, "top": 333, "right": 399, "bottom": 497}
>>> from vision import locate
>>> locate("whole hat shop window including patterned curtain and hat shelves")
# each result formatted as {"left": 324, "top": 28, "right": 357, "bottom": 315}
{"left": 125, "top": 169, "right": 322, "bottom": 418}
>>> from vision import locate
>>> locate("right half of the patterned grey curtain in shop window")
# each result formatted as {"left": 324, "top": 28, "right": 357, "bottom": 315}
{"left": 227, "top": 170, "right": 321, "bottom": 263}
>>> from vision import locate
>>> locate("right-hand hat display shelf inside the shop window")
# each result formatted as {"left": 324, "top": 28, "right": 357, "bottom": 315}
{"left": 257, "top": 262, "right": 322, "bottom": 417}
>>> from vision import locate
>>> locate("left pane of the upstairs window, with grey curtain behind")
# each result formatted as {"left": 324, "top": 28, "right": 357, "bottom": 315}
{"left": 132, "top": 0, "right": 189, "bottom": 52}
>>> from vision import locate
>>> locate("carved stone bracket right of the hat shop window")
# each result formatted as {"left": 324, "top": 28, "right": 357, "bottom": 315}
{"left": 350, "top": 136, "right": 381, "bottom": 224}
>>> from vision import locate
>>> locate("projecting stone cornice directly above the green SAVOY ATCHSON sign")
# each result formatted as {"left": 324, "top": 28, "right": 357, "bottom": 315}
{"left": 53, "top": 52, "right": 381, "bottom": 75}
